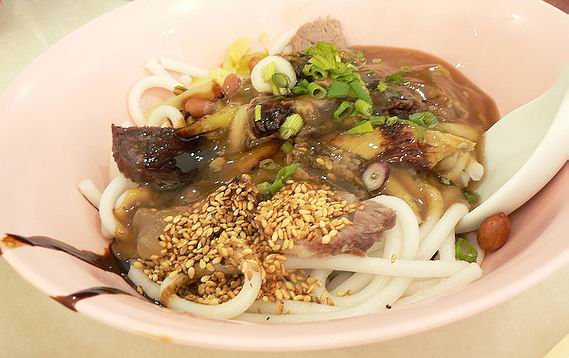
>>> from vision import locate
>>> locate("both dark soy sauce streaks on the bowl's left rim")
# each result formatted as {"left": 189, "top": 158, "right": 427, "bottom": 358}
{"left": 0, "top": 234, "right": 136, "bottom": 311}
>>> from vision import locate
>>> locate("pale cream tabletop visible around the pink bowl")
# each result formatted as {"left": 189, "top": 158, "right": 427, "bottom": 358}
{"left": 0, "top": 0, "right": 569, "bottom": 358}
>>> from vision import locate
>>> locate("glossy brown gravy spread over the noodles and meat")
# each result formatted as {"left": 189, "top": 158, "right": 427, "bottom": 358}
{"left": 112, "top": 46, "right": 499, "bottom": 260}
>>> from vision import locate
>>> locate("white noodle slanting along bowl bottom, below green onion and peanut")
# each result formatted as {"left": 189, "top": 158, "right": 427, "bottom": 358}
{"left": 397, "top": 263, "right": 482, "bottom": 305}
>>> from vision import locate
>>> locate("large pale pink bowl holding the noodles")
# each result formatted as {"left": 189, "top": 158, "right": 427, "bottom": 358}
{"left": 0, "top": 0, "right": 569, "bottom": 351}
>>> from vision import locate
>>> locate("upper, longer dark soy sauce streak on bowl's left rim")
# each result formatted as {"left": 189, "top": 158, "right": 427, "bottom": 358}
{"left": 3, "top": 234, "right": 127, "bottom": 275}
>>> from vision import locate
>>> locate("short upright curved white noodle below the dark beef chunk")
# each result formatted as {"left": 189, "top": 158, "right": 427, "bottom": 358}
{"left": 99, "top": 174, "right": 137, "bottom": 237}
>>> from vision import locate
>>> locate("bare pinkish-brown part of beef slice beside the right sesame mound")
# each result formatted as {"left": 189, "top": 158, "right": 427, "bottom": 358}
{"left": 294, "top": 200, "right": 396, "bottom": 257}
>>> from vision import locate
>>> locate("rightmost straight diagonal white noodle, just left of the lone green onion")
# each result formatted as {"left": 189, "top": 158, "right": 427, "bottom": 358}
{"left": 417, "top": 204, "right": 468, "bottom": 260}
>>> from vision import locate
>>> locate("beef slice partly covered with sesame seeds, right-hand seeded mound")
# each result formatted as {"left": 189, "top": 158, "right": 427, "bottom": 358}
{"left": 255, "top": 181, "right": 396, "bottom": 257}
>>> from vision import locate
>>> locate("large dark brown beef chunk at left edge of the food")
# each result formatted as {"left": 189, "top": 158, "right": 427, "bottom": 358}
{"left": 112, "top": 125, "right": 215, "bottom": 191}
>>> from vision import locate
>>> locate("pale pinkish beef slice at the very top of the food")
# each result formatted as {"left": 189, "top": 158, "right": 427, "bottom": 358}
{"left": 290, "top": 17, "right": 347, "bottom": 52}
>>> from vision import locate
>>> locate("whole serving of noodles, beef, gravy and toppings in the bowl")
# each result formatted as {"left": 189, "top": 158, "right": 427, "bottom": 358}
{"left": 5, "top": 19, "right": 507, "bottom": 322}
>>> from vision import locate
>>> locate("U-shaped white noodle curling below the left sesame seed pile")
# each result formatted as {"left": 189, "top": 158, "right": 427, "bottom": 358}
{"left": 160, "top": 262, "right": 262, "bottom": 319}
